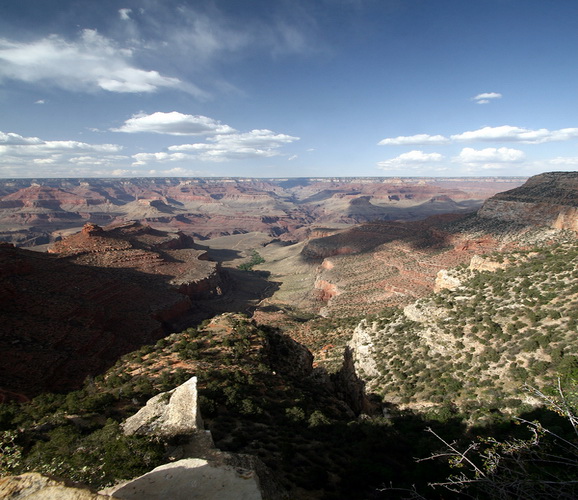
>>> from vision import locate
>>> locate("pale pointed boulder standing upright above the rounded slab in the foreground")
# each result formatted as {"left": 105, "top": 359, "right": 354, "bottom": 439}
{"left": 123, "top": 377, "right": 203, "bottom": 437}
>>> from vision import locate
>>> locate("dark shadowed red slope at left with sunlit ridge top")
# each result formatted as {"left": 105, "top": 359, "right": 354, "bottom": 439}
{"left": 0, "top": 224, "right": 225, "bottom": 395}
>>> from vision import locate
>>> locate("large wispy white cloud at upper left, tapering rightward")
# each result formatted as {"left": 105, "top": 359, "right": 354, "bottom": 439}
{"left": 0, "top": 29, "right": 194, "bottom": 96}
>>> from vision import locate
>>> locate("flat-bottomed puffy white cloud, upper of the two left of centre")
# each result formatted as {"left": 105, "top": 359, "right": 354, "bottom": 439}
{"left": 112, "top": 111, "right": 235, "bottom": 135}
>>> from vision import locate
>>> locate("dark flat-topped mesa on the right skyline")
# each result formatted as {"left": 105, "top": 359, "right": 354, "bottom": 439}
{"left": 478, "top": 172, "right": 578, "bottom": 231}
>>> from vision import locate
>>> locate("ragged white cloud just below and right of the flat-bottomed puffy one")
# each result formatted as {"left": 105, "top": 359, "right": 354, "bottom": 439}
{"left": 168, "top": 129, "right": 299, "bottom": 161}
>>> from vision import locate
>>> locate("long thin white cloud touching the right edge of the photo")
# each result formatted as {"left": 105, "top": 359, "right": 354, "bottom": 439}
{"left": 451, "top": 125, "right": 578, "bottom": 144}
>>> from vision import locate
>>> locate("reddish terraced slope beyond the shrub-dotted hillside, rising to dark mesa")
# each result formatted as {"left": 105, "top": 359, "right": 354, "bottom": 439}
{"left": 257, "top": 173, "right": 578, "bottom": 317}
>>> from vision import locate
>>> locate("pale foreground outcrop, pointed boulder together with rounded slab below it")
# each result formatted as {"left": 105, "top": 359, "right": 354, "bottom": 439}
{"left": 112, "top": 376, "right": 284, "bottom": 500}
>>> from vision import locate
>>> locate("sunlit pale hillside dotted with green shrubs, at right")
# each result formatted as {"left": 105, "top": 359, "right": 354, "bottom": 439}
{"left": 351, "top": 241, "right": 578, "bottom": 419}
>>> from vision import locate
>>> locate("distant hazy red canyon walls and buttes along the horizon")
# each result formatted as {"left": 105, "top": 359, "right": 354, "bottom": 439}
{"left": 0, "top": 177, "right": 523, "bottom": 246}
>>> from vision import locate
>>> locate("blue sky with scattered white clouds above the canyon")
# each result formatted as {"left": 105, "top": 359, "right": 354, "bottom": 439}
{"left": 0, "top": 0, "right": 578, "bottom": 178}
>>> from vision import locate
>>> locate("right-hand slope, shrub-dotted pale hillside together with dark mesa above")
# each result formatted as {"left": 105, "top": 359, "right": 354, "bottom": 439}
{"left": 342, "top": 172, "right": 578, "bottom": 418}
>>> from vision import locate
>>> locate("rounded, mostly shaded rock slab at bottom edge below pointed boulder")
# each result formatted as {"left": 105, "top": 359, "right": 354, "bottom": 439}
{"left": 104, "top": 458, "right": 263, "bottom": 500}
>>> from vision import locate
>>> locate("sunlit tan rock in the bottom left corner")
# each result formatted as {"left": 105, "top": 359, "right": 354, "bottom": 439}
{"left": 0, "top": 472, "right": 114, "bottom": 500}
